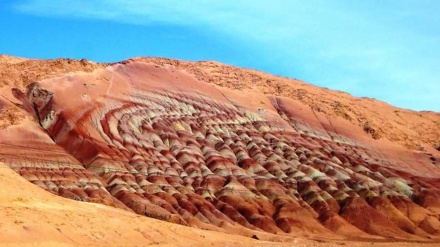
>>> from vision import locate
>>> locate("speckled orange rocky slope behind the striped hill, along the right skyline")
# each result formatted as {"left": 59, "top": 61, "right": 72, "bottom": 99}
{"left": 134, "top": 58, "right": 440, "bottom": 151}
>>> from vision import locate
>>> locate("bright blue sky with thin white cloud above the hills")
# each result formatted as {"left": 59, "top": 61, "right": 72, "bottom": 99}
{"left": 0, "top": 0, "right": 440, "bottom": 112}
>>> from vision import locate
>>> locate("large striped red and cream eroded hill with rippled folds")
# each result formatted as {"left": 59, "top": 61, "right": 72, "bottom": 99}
{"left": 0, "top": 56, "right": 440, "bottom": 241}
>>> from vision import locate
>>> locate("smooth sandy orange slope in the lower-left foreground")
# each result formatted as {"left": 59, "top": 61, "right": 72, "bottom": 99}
{"left": 0, "top": 163, "right": 292, "bottom": 247}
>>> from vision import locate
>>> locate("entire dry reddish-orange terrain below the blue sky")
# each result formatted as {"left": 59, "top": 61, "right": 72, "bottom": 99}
{"left": 0, "top": 56, "right": 440, "bottom": 246}
